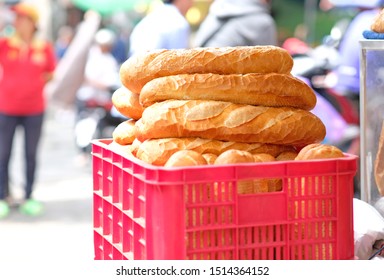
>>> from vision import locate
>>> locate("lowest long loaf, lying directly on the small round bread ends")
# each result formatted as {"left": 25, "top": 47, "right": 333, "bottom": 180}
{"left": 134, "top": 137, "right": 294, "bottom": 166}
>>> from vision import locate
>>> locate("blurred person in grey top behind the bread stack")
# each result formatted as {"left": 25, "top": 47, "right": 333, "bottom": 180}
{"left": 194, "top": 0, "right": 278, "bottom": 47}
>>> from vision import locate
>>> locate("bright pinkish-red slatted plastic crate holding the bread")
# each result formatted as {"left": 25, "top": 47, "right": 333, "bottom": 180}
{"left": 92, "top": 139, "right": 357, "bottom": 260}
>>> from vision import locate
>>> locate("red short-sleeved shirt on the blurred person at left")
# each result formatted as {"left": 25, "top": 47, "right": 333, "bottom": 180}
{"left": 0, "top": 36, "right": 56, "bottom": 116}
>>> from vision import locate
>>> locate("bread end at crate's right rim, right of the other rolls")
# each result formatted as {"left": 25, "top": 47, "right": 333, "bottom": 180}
{"left": 295, "top": 143, "right": 344, "bottom": 160}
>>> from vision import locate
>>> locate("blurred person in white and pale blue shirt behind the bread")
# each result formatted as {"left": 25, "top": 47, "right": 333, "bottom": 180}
{"left": 129, "top": 0, "right": 193, "bottom": 56}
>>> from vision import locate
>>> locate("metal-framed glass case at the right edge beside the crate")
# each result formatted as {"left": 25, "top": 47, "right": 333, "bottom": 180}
{"left": 360, "top": 40, "right": 384, "bottom": 205}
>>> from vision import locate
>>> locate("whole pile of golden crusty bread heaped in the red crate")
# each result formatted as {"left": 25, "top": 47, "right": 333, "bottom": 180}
{"left": 112, "top": 46, "right": 343, "bottom": 192}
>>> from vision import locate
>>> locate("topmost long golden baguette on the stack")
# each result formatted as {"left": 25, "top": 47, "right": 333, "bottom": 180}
{"left": 120, "top": 46, "right": 293, "bottom": 93}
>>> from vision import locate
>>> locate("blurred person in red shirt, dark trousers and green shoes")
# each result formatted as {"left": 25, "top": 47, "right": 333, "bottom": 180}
{"left": 0, "top": 3, "right": 56, "bottom": 218}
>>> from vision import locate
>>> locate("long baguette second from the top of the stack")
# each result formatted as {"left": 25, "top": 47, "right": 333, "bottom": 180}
{"left": 139, "top": 73, "right": 316, "bottom": 110}
